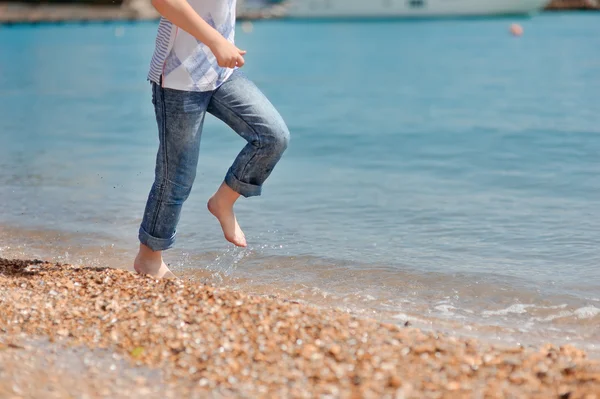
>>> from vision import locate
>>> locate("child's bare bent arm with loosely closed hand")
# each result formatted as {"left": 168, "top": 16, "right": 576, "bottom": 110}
{"left": 152, "top": 0, "right": 246, "bottom": 68}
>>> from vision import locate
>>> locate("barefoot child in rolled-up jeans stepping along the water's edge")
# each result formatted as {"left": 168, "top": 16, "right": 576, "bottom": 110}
{"left": 134, "top": 0, "right": 289, "bottom": 277}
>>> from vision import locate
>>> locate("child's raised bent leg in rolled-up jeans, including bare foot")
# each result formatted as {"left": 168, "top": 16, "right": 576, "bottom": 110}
{"left": 208, "top": 70, "right": 290, "bottom": 246}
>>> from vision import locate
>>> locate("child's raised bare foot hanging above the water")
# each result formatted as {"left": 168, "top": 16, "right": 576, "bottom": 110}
{"left": 207, "top": 183, "right": 247, "bottom": 247}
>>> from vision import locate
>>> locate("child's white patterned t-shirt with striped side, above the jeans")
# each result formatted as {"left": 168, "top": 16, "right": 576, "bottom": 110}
{"left": 148, "top": 0, "right": 236, "bottom": 91}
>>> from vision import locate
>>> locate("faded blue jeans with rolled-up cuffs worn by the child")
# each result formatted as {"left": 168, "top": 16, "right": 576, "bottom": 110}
{"left": 139, "top": 70, "right": 290, "bottom": 251}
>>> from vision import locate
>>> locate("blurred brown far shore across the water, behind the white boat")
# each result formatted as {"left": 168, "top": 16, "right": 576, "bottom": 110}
{"left": 0, "top": 0, "right": 600, "bottom": 25}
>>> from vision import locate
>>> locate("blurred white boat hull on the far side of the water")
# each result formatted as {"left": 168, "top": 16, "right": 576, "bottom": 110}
{"left": 285, "top": 0, "right": 550, "bottom": 18}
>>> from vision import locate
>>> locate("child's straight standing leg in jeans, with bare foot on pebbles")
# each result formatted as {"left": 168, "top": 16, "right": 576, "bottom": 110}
{"left": 134, "top": 84, "right": 212, "bottom": 277}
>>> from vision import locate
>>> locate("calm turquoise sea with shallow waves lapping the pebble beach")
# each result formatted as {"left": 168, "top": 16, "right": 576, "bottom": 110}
{"left": 0, "top": 13, "right": 600, "bottom": 350}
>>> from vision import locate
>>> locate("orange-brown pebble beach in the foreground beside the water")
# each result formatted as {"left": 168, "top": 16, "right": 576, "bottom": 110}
{"left": 0, "top": 259, "right": 600, "bottom": 399}
